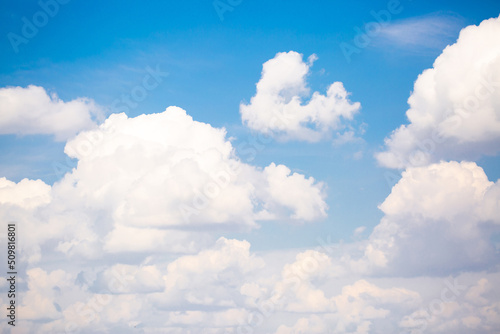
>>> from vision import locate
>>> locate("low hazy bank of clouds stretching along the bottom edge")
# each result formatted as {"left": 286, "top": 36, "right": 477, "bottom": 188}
{"left": 0, "top": 226, "right": 500, "bottom": 334}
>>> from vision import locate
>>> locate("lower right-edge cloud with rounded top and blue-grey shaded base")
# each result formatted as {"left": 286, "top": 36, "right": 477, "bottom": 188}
{"left": 353, "top": 162, "right": 500, "bottom": 275}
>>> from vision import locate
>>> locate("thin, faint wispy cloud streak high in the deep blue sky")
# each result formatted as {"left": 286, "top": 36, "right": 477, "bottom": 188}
{"left": 375, "top": 13, "right": 463, "bottom": 51}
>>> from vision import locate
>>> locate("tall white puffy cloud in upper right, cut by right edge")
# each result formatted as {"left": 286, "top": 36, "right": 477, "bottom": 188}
{"left": 377, "top": 18, "right": 500, "bottom": 168}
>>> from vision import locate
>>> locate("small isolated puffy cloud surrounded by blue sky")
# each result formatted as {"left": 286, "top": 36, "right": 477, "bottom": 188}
{"left": 240, "top": 51, "right": 361, "bottom": 142}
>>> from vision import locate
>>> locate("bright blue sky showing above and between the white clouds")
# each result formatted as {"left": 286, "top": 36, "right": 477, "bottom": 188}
{"left": 0, "top": 0, "right": 500, "bottom": 248}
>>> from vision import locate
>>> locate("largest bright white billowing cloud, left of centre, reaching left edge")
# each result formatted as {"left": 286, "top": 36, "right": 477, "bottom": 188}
{"left": 0, "top": 107, "right": 327, "bottom": 272}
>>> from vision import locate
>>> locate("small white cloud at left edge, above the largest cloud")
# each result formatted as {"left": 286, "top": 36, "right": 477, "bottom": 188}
{"left": 0, "top": 85, "right": 102, "bottom": 141}
